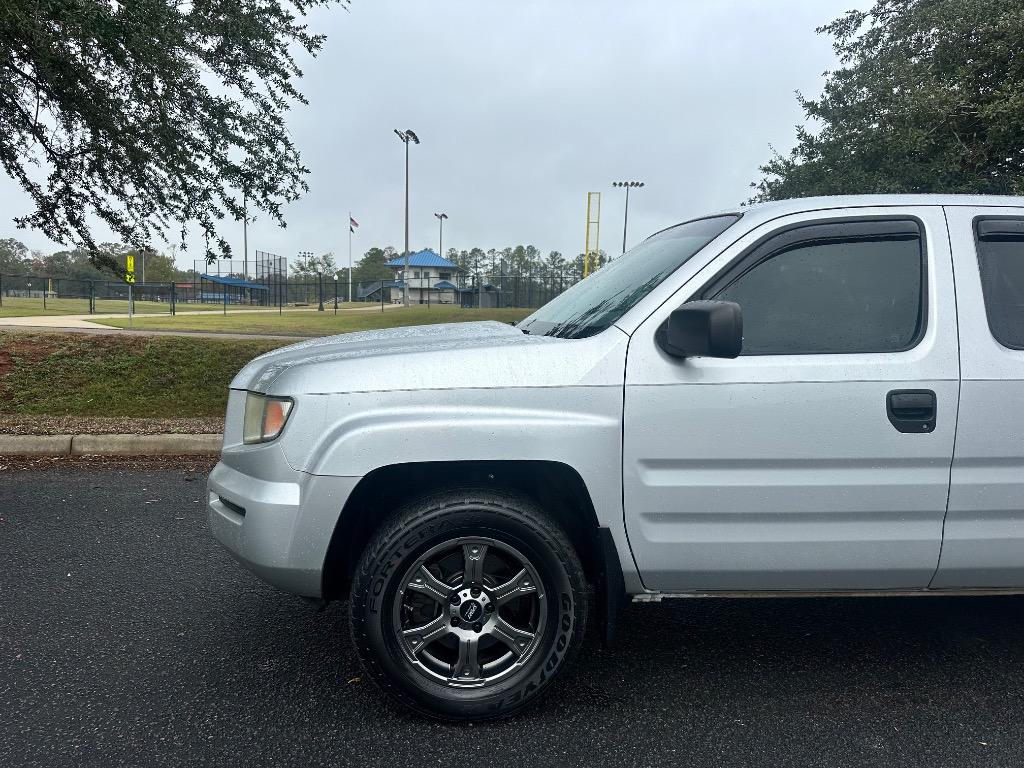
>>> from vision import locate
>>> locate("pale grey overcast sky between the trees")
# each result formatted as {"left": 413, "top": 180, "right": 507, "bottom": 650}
{"left": 0, "top": 0, "right": 867, "bottom": 266}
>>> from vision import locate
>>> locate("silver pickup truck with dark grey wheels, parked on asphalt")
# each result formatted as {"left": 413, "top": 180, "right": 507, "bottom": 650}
{"left": 208, "top": 196, "right": 1024, "bottom": 719}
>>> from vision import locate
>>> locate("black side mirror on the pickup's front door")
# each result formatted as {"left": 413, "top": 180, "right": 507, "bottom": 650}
{"left": 655, "top": 301, "right": 743, "bottom": 358}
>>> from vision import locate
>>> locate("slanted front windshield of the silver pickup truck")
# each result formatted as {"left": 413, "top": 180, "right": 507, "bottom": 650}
{"left": 518, "top": 214, "right": 739, "bottom": 339}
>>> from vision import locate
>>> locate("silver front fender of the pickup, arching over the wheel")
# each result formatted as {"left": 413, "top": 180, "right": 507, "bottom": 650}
{"left": 302, "top": 386, "right": 639, "bottom": 589}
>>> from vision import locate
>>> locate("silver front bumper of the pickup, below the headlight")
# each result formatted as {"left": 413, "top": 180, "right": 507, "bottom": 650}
{"left": 207, "top": 457, "right": 360, "bottom": 598}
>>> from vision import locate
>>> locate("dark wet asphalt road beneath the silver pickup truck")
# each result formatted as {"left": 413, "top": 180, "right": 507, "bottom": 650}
{"left": 0, "top": 465, "right": 1024, "bottom": 768}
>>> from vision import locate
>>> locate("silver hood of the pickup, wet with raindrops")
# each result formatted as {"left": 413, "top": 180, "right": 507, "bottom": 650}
{"left": 231, "top": 319, "right": 628, "bottom": 395}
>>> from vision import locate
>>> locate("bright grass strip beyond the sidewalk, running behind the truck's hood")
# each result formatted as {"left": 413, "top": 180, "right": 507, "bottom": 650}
{"left": 96, "top": 305, "right": 532, "bottom": 336}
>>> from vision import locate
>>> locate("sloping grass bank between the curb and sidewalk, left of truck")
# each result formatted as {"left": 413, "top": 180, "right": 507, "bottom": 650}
{"left": 0, "top": 331, "right": 287, "bottom": 419}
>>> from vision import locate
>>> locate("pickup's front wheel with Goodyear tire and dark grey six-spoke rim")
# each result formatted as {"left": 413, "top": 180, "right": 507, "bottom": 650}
{"left": 349, "top": 488, "right": 590, "bottom": 721}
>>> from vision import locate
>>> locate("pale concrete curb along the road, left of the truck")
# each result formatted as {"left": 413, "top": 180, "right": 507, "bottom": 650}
{"left": 0, "top": 434, "right": 224, "bottom": 456}
